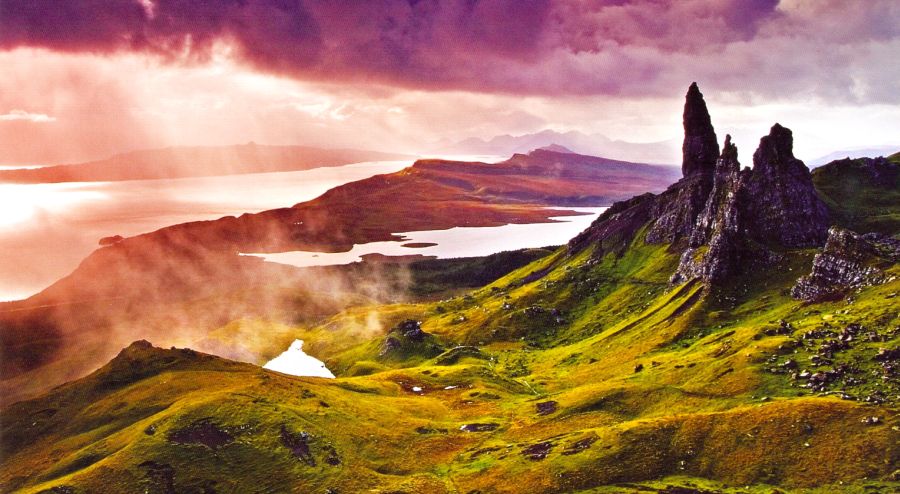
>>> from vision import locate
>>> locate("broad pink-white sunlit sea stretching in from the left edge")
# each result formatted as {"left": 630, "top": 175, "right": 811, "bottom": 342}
{"left": 0, "top": 160, "right": 412, "bottom": 300}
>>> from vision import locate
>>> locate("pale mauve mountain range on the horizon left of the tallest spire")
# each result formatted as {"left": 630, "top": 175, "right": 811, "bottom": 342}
{"left": 435, "top": 130, "right": 681, "bottom": 164}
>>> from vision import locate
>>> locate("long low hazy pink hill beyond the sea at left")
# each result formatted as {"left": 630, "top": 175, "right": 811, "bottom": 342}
{"left": 0, "top": 143, "right": 411, "bottom": 183}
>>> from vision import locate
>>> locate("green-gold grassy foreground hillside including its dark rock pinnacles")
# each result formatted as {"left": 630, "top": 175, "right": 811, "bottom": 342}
{"left": 0, "top": 86, "right": 900, "bottom": 494}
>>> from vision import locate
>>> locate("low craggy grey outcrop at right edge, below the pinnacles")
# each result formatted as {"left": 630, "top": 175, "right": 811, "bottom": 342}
{"left": 791, "top": 227, "right": 900, "bottom": 302}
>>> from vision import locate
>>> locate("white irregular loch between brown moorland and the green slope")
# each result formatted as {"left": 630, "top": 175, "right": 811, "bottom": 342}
{"left": 244, "top": 208, "right": 607, "bottom": 267}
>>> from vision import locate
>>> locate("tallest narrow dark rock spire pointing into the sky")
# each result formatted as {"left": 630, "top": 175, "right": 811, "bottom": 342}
{"left": 681, "top": 82, "right": 719, "bottom": 177}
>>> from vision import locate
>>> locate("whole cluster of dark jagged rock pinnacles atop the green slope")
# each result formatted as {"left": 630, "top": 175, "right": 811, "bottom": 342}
{"left": 570, "top": 83, "right": 829, "bottom": 284}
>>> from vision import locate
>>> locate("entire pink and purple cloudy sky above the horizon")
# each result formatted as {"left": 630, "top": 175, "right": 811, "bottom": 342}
{"left": 0, "top": 0, "right": 900, "bottom": 164}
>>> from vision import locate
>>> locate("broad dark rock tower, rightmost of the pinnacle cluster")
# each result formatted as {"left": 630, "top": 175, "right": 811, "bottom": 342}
{"left": 747, "top": 124, "right": 829, "bottom": 247}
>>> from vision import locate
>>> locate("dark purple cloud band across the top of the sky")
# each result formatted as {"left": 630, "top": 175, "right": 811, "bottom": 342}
{"left": 0, "top": 0, "right": 900, "bottom": 101}
